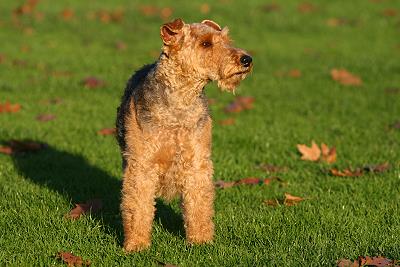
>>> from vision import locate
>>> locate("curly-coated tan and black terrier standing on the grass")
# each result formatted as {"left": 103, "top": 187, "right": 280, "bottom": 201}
{"left": 116, "top": 19, "right": 253, "bottom": 252}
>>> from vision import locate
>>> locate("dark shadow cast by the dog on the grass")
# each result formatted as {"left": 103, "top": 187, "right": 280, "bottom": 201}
{"left": 9, "top": 142, "right": 183, "bottom": 243}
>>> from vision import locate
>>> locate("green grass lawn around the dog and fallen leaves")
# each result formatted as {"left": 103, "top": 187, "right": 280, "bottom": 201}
{"left": 0, "top": 0, "right": 400, "bottom": 266}
